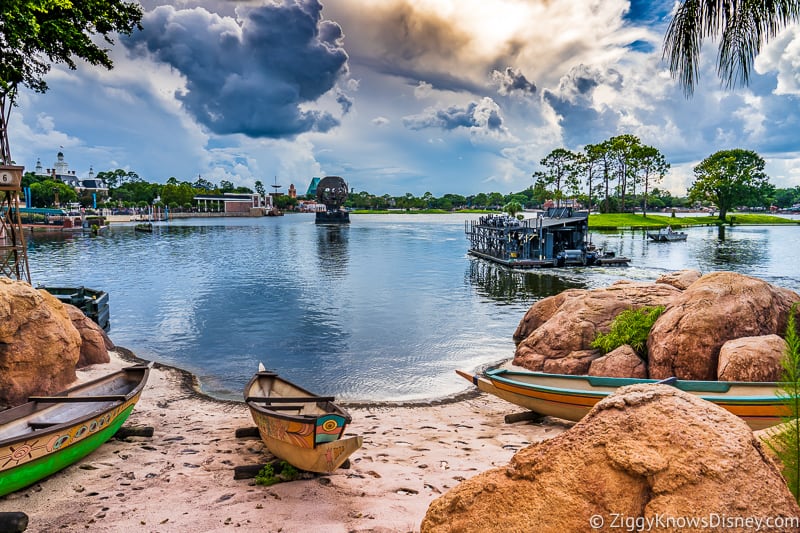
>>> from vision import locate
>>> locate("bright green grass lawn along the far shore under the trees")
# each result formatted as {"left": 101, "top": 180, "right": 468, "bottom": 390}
{"left": 589, "top": 213, "right": 800, "bottom": 229}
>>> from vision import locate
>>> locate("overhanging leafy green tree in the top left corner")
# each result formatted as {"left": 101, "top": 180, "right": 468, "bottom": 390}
{"left": 0, "top": 0, "right": 142, "bottom": 164}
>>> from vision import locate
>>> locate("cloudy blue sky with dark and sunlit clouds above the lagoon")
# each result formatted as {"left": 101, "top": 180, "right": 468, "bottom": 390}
{"left": 9, "top": 0, "right": 800, "bottom": 196}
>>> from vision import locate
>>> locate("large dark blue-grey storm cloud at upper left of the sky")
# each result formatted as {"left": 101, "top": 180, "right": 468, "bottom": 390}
{"left": 123, "top": 0, "right": 347, "bottom": 138}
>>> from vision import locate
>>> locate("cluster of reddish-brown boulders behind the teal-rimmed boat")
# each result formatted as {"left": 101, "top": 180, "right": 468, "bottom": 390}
{"left": 514, "top": 270, "right": 800, "bottom": 381}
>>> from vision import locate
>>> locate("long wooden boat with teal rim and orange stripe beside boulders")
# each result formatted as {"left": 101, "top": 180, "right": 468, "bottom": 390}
{"left": 456, "top": 368, "right": 787, "bottom": 430}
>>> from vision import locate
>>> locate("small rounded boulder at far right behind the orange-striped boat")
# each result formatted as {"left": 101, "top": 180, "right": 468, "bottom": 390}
{"left": 717, "top": 335, "right": 787, "bottom": 381}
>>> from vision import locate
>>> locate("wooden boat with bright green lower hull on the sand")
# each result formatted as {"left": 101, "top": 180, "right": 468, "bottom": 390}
{"left": 0, "top": 365, "right": 150, "bottom": 496}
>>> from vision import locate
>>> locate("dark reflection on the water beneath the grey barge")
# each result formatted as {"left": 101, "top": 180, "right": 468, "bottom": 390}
{"left": 467, "top": 258, "right": 586, "bottom": 304}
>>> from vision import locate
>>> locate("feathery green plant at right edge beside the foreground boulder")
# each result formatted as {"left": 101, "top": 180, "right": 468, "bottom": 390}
{"left": 767, "top": 303, "right": 800, "bottom": 503}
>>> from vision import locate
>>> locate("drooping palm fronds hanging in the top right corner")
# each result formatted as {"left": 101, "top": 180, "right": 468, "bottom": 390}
{"left": 663, "top": 0, "right": 800, "bottom": 96}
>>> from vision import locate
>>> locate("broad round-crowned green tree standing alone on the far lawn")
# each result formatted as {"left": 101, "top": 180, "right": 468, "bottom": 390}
{"left": 689, "top": 148, "right": 770, "bottom": 221}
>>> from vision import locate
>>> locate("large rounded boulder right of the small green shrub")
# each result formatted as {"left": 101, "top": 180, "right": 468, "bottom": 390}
{"left": 647, "top": 272, "right": 800, "bottom": 380}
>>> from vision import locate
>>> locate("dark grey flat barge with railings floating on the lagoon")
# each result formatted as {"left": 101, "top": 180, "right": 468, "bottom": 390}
{"left": 464, "top": 207, "right": 630, "bottom": 269}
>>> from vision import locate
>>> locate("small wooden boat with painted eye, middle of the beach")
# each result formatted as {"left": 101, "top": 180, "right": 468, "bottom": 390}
{"left": 244, "top": 364, "right": 363, "bottom": 474}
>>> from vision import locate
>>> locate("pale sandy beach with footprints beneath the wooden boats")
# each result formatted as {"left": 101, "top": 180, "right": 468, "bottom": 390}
{"left": 0, "top": 349, "right": 565, "bottom": 532}
